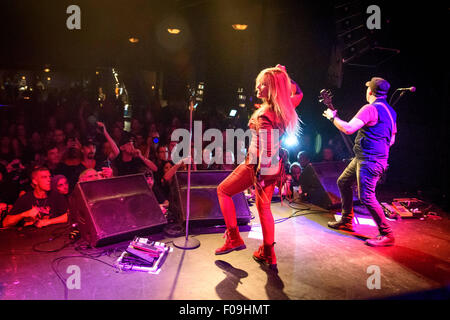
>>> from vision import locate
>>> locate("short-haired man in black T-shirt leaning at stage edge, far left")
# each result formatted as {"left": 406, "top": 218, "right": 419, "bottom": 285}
{"left": 3, "top": 167, "right": 68, "bottom": 228}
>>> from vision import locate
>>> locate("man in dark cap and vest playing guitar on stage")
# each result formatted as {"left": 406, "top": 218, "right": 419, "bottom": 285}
{"left": 323, "top": 77, "right": 397, "bottom": 247}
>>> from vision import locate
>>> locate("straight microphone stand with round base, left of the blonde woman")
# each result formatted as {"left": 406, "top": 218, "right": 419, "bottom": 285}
{"left": 173, "top": 99, "right": 200, "bottom": 250}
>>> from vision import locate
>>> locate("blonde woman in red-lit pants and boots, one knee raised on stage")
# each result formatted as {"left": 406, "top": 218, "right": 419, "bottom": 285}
{"left": 216, "top": 65, "right": 303, "bottom": 271}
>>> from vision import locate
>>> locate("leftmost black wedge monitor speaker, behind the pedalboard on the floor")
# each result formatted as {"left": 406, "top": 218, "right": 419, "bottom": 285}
{"left": 69, "top": 174, "right": 167, "bottom": 247}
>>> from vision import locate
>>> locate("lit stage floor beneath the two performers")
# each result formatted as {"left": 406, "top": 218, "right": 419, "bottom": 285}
{"left": 0, "top": 201, "right": 450, "bottom": 300}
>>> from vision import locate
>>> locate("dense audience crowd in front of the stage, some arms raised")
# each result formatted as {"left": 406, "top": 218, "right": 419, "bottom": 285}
{"left": 0, "top": 74, "right": 346, "bottom": 228}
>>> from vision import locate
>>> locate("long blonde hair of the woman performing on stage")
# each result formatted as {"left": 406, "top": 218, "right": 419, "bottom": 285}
{"left": 254, "top": 68, "right": 300, "bottom": 135}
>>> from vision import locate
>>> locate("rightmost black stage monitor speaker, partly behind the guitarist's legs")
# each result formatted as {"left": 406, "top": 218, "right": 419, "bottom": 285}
{"left": 300, "top": 161, "right": 358, "bottom": 209}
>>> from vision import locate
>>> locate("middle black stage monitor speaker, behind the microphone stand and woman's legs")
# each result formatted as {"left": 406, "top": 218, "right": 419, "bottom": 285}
{"left": 171, "top": 170, "right": 251, "bottom": 226}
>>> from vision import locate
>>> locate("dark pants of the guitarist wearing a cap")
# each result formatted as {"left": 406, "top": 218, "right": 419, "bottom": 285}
{"left": 337, "top": 158, "right": 392, "bottom": 235}
